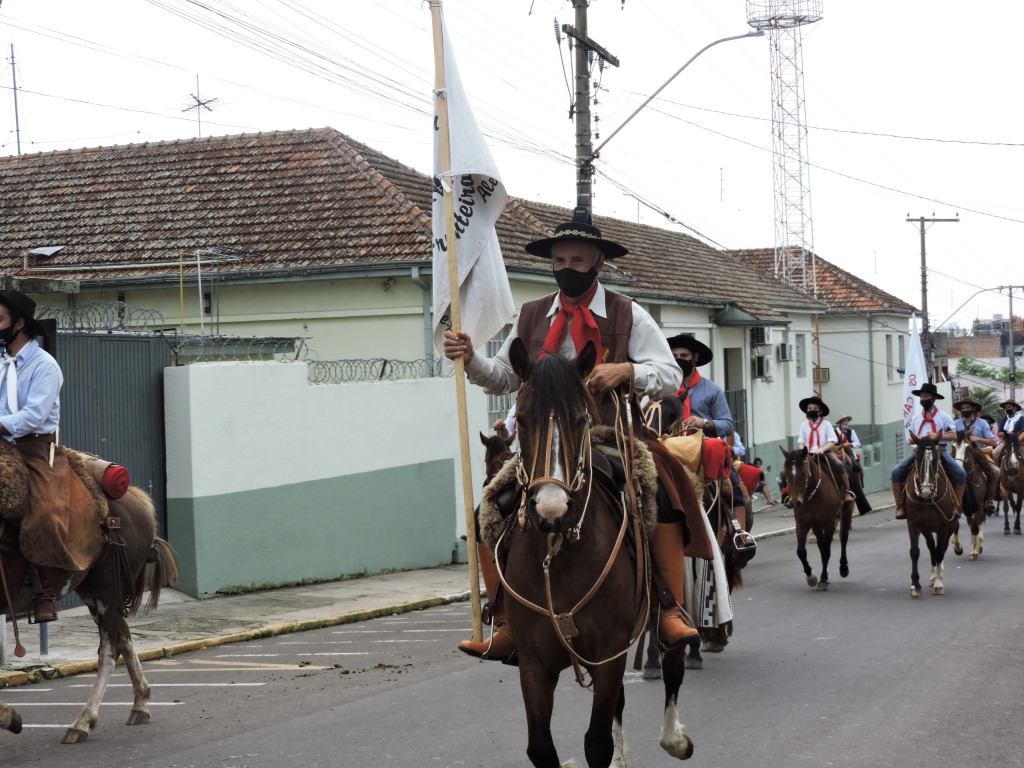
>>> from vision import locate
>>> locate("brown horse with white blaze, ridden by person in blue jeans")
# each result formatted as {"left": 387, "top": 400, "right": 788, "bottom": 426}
{"left": 905, "top": 432, "right": 959, "bottom": 597}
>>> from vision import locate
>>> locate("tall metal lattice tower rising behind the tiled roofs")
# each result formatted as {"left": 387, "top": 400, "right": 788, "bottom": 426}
{"left": 746, "top": 0, "right": 821, "bottom": 296}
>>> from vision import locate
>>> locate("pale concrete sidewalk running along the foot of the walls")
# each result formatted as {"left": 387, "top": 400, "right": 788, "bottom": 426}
{"left": 0, "top": 492, "right": 894, "bottom": 687}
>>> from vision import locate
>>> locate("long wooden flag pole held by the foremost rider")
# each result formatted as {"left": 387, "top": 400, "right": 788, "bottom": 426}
{"left": 430, "top": 0, "right": 483, "bottom": 642}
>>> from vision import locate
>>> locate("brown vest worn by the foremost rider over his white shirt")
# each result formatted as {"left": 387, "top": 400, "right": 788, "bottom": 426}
{"left": 518, "top": 289, "right": 642, "bottom": 428}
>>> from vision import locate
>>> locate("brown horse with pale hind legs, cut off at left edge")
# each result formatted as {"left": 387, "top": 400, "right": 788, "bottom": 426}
{"left": 0, "top": 448, "right": 178, "bottom": 743}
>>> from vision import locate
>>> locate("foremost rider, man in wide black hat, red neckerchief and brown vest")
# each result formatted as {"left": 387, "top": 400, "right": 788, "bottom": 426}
{"left": 444, "top": 215, "right": 712, "bottom": 660}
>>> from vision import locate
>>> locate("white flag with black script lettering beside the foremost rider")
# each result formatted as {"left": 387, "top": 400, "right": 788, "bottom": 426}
{"left": 433, "top": 16, "right": 515, "bottom": 351}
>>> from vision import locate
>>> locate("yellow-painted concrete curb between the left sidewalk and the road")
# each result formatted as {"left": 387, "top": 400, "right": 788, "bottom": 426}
{"left": 0, "top": 590, "right": 470, "bottom": 688}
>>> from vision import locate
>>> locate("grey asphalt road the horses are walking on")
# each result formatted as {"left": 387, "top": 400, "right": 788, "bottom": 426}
{"left": 0, "top": 515, "right": 1024, "bottom": 768}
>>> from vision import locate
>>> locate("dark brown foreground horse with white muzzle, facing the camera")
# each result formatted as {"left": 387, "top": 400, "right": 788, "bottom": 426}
{"left": 499, "top": 340, "right": 693, "bottom": 768}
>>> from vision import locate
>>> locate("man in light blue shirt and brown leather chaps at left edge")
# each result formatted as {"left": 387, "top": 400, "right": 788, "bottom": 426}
{"left": 0, "top": 290, "right": 77, "bottom": 623}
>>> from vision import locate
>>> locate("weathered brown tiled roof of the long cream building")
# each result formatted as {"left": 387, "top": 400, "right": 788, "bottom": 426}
{"left": 0, "top": 128, "right": 839, "bottom": 323}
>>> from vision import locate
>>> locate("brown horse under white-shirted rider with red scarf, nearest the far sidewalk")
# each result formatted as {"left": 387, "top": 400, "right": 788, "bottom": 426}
{"left": 779, "top": 446, "right": 854, "bottom": 591}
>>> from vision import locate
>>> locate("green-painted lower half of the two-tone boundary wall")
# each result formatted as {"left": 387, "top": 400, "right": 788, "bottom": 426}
{"left": 167, "top": 460, "right": 457, "bottom": 598}
